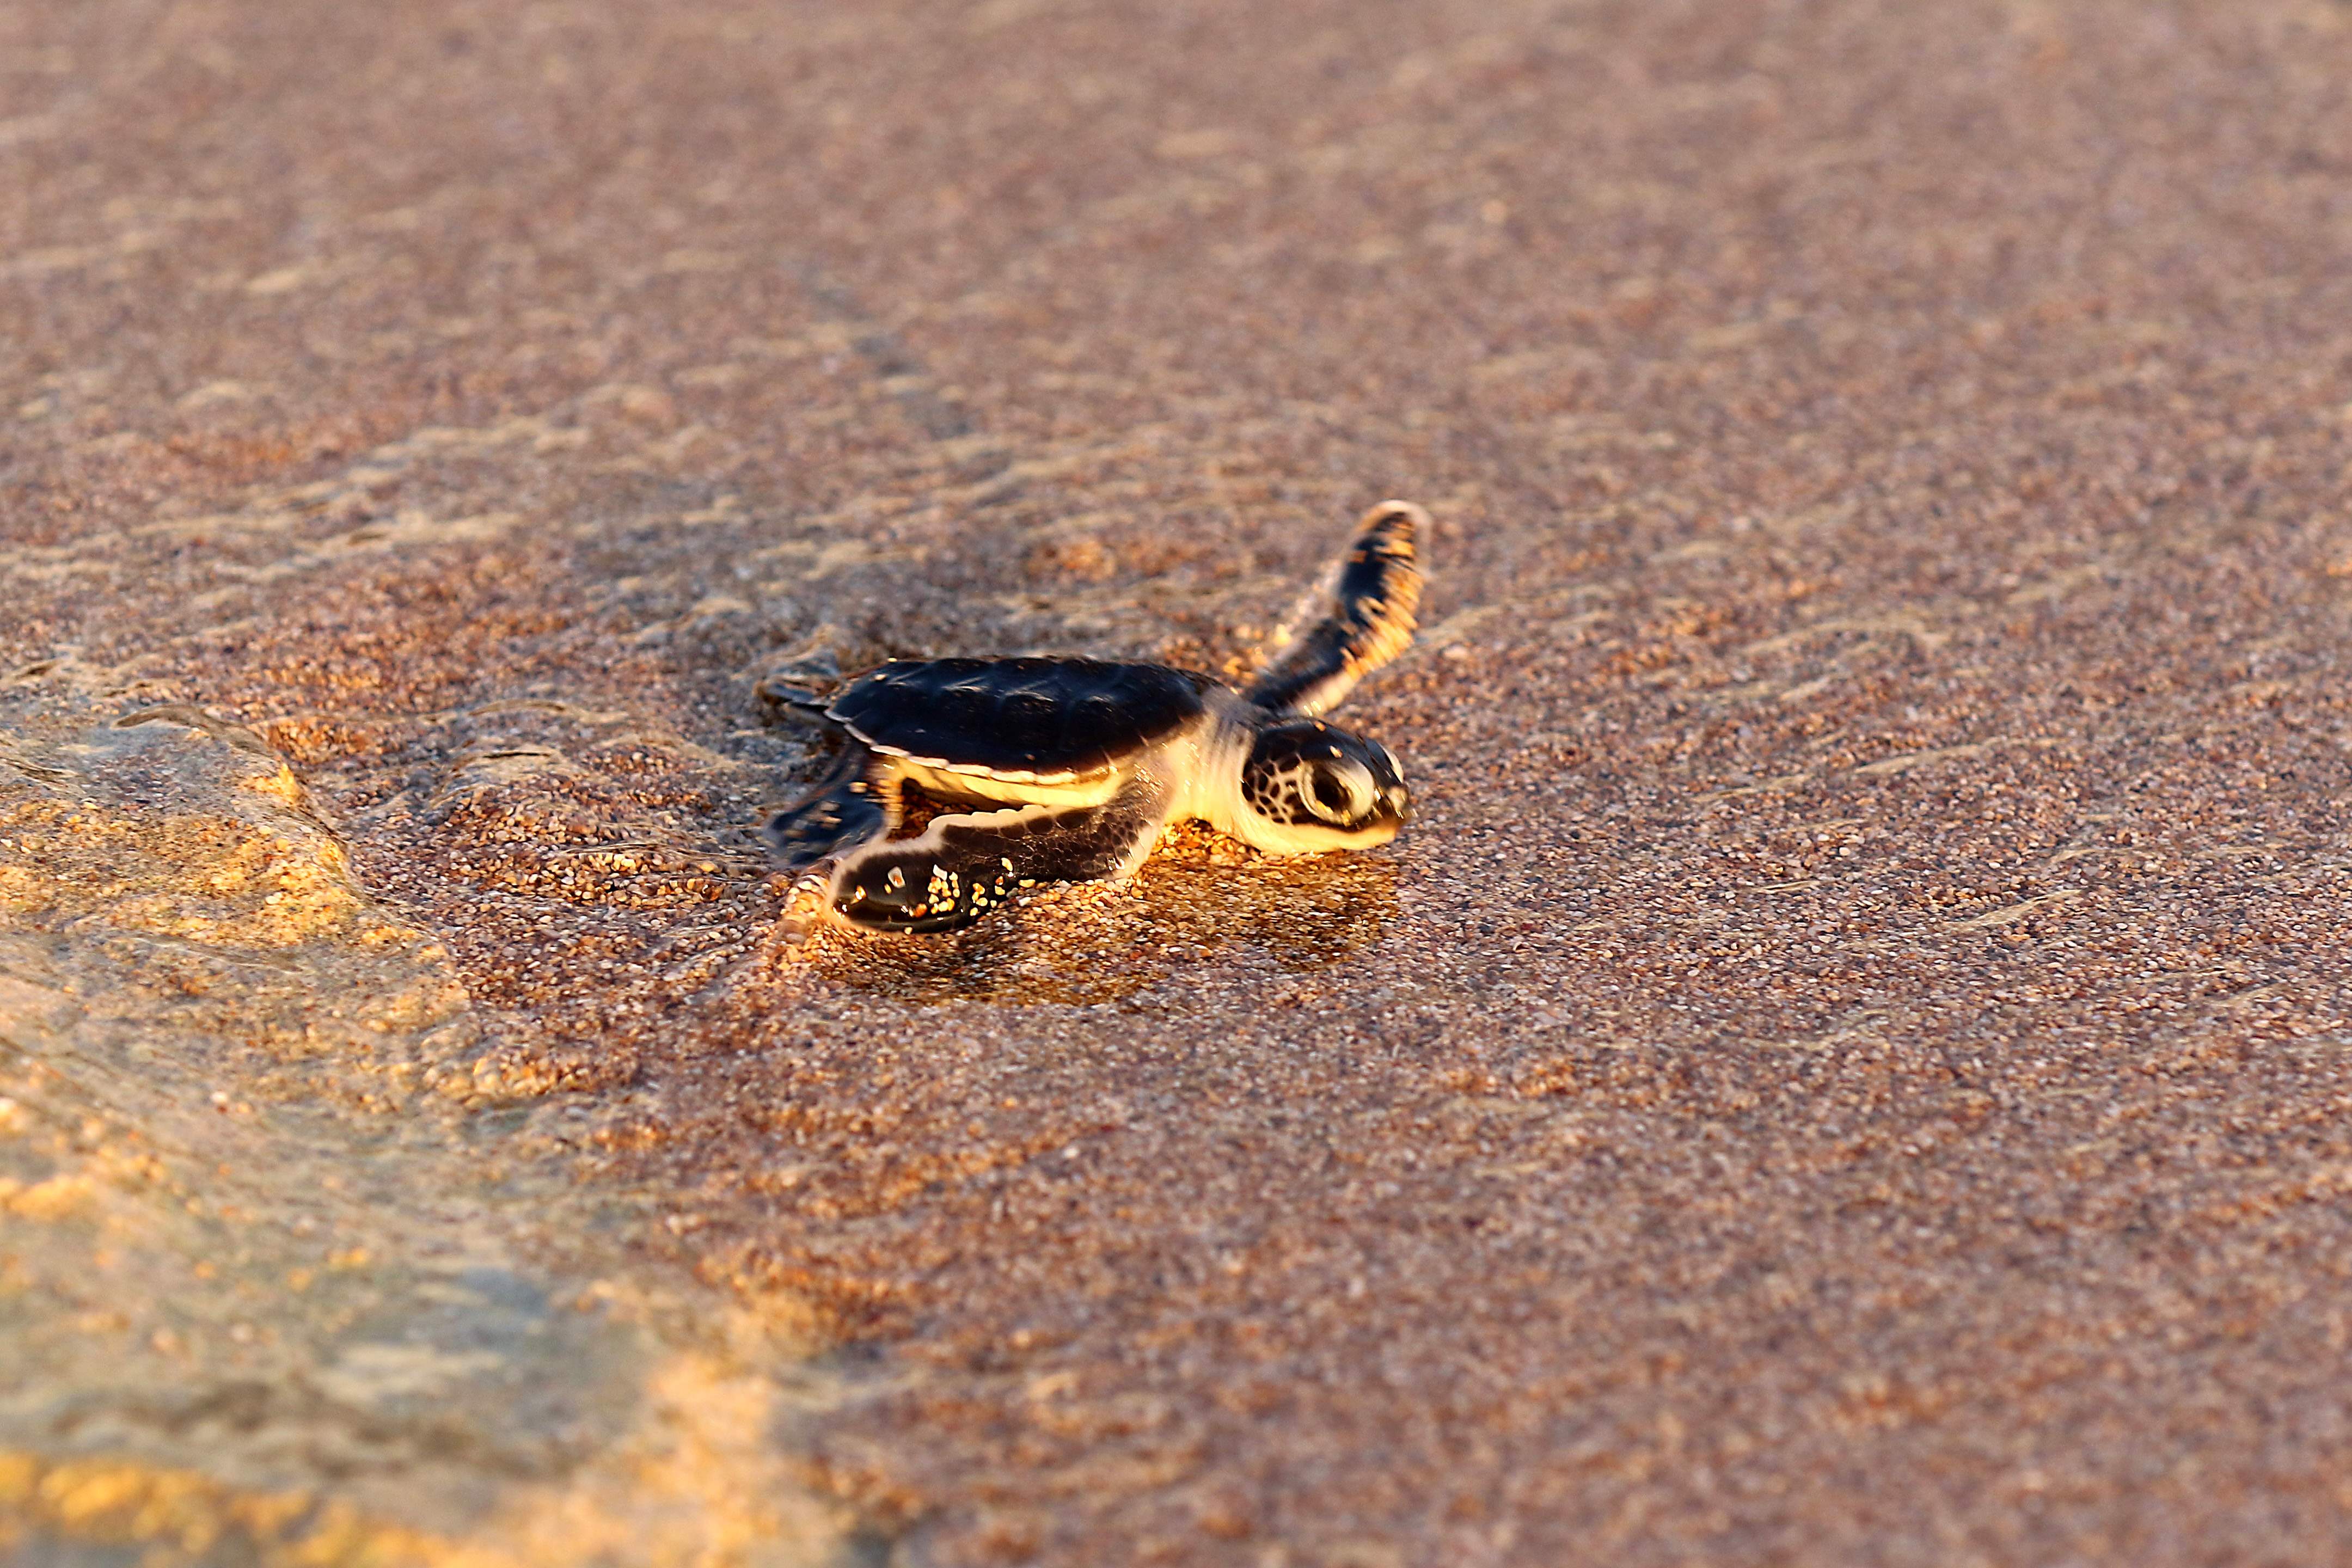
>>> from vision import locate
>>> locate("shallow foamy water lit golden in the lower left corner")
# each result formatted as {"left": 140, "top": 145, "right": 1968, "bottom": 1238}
{"left": 0, "top": 708, "right": 840, "bottom": 1563}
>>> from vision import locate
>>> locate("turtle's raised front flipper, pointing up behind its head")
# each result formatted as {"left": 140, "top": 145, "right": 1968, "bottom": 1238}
{"left": 1242, "top": 501, "right": 1430, "bottom": 719}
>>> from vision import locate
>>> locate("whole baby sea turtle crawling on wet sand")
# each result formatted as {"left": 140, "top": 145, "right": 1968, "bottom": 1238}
{"left": 759, "top": 501, "right": 1430, "bottom": 940}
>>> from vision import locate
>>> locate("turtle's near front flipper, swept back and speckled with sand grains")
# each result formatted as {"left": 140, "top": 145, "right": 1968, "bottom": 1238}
{"left": 832, "top": 785, "right": 1164, "bottom": 931}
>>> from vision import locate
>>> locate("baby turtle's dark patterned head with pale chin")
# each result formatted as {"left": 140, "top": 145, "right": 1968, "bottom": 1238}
{"left": 1235, "top": 719, "right": 1411, "bottom": 856}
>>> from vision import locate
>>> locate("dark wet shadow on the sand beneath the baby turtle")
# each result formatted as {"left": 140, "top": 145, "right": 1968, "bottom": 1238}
{"left": 828, "top": 844, "right": 1397, "bottom": 1006}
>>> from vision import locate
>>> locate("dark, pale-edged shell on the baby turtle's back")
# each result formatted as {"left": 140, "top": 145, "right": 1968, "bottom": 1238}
{"left": 828, "top": 658, "right": 1211, "bottom": 783}
